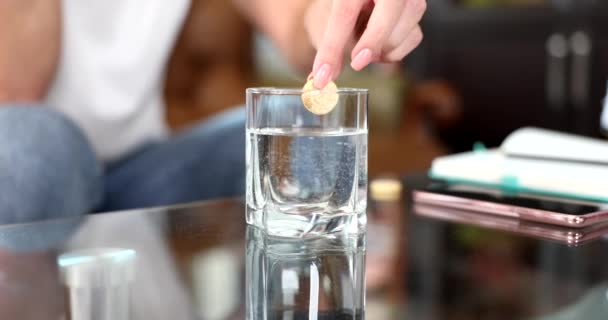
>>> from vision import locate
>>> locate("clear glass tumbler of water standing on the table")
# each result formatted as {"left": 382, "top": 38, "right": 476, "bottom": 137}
{"left": 247, "top": 88, "right": 368, "bottom": 237}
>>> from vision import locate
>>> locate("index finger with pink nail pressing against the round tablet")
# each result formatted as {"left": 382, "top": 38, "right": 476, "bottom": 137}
{"left": 311, "top": 0, "right": 365, "bottom": 88}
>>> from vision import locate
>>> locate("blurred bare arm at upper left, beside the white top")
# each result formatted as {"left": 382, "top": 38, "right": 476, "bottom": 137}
{"left": 0, "top": 0, "right": 61, "bottom": 103}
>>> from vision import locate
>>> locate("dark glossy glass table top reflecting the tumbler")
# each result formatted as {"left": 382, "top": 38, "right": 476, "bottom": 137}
{"left": 0, "top": 179, "right": 608, "bottom": 320}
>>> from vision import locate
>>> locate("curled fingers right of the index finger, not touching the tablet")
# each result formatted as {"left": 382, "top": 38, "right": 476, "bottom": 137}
{"left": 351, "top": 0, "right": 426, "bottom": 70}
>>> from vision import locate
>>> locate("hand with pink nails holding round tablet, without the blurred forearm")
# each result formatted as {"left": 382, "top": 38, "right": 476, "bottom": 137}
{"left": 305, "top": 0, "right": 426, "bottom": 88}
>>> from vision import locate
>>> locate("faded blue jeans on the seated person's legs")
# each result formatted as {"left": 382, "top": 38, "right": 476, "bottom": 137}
{"left": 0, "top": 106, "right": 245, "bottom": 224}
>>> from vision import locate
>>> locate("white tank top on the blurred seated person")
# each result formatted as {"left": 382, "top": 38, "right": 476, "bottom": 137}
{"left": 46, "top": 0, "right": 190, "bottom": 160}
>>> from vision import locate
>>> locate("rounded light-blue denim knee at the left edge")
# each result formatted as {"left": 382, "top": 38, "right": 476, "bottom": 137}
{"left": 0, "top": 106, "right": 101, "bottom": 223}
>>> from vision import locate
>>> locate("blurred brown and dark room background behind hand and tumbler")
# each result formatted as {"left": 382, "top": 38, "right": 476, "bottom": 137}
{"left": 166, "top": 0, "right": 608, "bottom": 176}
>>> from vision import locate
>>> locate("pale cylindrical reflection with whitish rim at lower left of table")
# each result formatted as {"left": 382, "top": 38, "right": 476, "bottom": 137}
{"left": 58, "top": 248, "right": 135, "bottom": 320}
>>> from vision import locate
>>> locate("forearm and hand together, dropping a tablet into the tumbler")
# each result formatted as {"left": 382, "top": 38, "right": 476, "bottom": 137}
{"left": 234, "top": 0, "right": 426, "bottom": 88}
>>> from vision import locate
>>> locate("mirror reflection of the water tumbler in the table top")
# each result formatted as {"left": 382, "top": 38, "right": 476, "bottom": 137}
{"left": 246, "top": 227, "right": 365, "bottom": 320}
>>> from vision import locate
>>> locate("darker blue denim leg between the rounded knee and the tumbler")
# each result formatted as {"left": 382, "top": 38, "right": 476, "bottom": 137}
{"left": 99, "top": 108, "right": 245, "bottom": 211}
